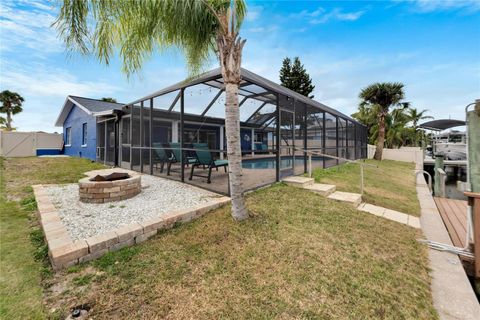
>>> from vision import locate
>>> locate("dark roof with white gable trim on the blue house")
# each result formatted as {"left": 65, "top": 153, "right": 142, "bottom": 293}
{"left": 55, "top": 96, "right": 124, "bottom": 127}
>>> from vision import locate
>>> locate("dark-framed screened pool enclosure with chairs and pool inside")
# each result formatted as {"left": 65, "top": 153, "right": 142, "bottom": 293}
{"left": 97, "top": 69, "right": 367, "bottom": 194}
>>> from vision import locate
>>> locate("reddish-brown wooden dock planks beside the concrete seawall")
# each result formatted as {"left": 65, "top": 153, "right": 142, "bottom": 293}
{"left": 434, "top": 197, "right": 467, "bottom": 248}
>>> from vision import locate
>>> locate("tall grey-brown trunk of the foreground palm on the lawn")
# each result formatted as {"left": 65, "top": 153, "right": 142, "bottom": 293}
{"left": 217, "top": 34, "right": 249, "bottom": 221}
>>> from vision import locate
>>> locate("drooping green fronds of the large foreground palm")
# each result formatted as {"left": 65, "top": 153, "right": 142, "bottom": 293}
{"left": 54, "top": 0, "right": 246, "bottom": 75}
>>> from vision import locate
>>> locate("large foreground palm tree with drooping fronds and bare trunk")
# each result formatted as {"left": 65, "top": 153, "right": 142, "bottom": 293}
{"left": 54, "top": 0, "right": 248, "bottom": 220}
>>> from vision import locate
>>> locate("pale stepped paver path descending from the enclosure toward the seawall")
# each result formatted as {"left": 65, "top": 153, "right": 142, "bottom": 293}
{"left": 283, "top": 176, "right": 420, "bottom": 229}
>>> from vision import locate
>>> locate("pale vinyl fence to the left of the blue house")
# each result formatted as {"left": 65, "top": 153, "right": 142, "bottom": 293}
{"left": 0, "top": 131, "right": 63, "bottom": 157}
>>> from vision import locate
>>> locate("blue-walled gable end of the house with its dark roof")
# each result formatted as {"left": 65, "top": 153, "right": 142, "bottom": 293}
{"left": 55, "top": 96, "right": 123, "bottom": 160}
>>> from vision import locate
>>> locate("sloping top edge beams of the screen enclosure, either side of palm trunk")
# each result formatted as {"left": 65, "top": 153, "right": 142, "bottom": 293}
{"left": 128, "top": 68, "right": 363, "bottom": 125}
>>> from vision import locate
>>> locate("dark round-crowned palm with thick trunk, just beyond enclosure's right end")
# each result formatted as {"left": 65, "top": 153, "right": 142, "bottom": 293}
{"left": 360, "top": 82, "right": 406, "bottom": 160}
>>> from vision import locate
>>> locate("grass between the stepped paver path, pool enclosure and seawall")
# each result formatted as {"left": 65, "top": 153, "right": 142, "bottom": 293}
{"left": 313, "top": 160, "right": 420, "bottom": 216}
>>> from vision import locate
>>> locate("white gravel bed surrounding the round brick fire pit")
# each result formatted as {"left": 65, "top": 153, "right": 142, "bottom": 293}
{"left": 45, "top": 175, "right": 218, "bottom": 240}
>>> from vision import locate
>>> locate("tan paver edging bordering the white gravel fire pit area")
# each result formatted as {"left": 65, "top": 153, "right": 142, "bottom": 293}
{"left": 32, "top": 185, "right": 230, "bottom": 270}
